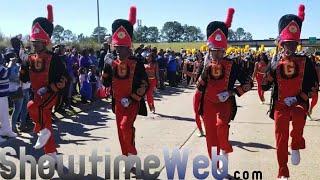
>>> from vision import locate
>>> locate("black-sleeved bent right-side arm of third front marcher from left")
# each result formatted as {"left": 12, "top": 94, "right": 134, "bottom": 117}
{"left": 231, "top": 63, "right": 253, "bottom": 97}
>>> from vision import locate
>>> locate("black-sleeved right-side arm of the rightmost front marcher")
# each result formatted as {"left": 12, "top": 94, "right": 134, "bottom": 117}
{"left": 296, "top": 57, "right": 319, "bottom": 102}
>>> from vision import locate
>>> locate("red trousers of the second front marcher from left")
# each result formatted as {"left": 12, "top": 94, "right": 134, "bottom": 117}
{"left": 115, "top": 101, "right": 139, "bottom": 156}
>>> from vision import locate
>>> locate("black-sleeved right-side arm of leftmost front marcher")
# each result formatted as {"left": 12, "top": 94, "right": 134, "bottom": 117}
{"left": 47, "top": 54, "right": 68, "bottom": 92}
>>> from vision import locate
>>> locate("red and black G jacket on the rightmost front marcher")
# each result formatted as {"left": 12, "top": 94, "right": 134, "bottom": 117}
{"left": 261, "top": 55, "right": 319, "bottom": 119}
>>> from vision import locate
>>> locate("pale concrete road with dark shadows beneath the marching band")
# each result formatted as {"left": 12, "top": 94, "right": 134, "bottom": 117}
{"left": 0, "top": 83, "right": 320, "bottom": 180}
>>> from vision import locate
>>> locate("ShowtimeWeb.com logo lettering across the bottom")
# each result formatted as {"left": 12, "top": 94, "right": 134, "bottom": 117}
{"left": 0, "top": 147, "right": 262, "bottom": 179}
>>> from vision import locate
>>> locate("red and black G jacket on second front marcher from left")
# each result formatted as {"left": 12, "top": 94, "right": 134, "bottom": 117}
{"left": 102, "top": 56, "right": 149, "bottom": 116}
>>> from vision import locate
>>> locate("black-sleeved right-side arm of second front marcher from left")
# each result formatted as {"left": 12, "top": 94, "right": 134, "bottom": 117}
{"left": 129, "top": 60, "right": 149, "bottom": 101}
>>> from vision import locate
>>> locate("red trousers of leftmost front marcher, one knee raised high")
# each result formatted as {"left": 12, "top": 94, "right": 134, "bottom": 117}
{"left": 28, "top": 93, "right": 58, "bottom": 154}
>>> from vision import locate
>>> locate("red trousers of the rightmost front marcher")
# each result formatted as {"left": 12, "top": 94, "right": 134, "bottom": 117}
{"left": 274, "top": 101, "right": 307, "bottom": 178}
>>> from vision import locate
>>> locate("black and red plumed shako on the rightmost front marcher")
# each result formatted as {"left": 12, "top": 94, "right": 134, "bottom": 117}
{"left": 278, "top": 4, "right": 305, "bottom": 46}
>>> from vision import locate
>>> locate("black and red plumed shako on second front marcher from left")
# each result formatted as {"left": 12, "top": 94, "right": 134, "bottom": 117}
{"left": 112, "top": 6, "right": 137, "bottom": 47}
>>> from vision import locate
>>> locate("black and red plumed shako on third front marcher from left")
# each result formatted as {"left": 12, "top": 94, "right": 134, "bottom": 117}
{"left": 207, "top": 8, "right": 234, "bottom": 49}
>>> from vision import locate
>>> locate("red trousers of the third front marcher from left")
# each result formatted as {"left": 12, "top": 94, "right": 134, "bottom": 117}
{"left": 203, "top": 98, "right": 233, "bottom": 158}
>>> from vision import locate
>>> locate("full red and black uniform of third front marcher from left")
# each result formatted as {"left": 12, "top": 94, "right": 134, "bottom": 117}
{"left": 198, "top": 57, "right": 253, "bottom": 157}
